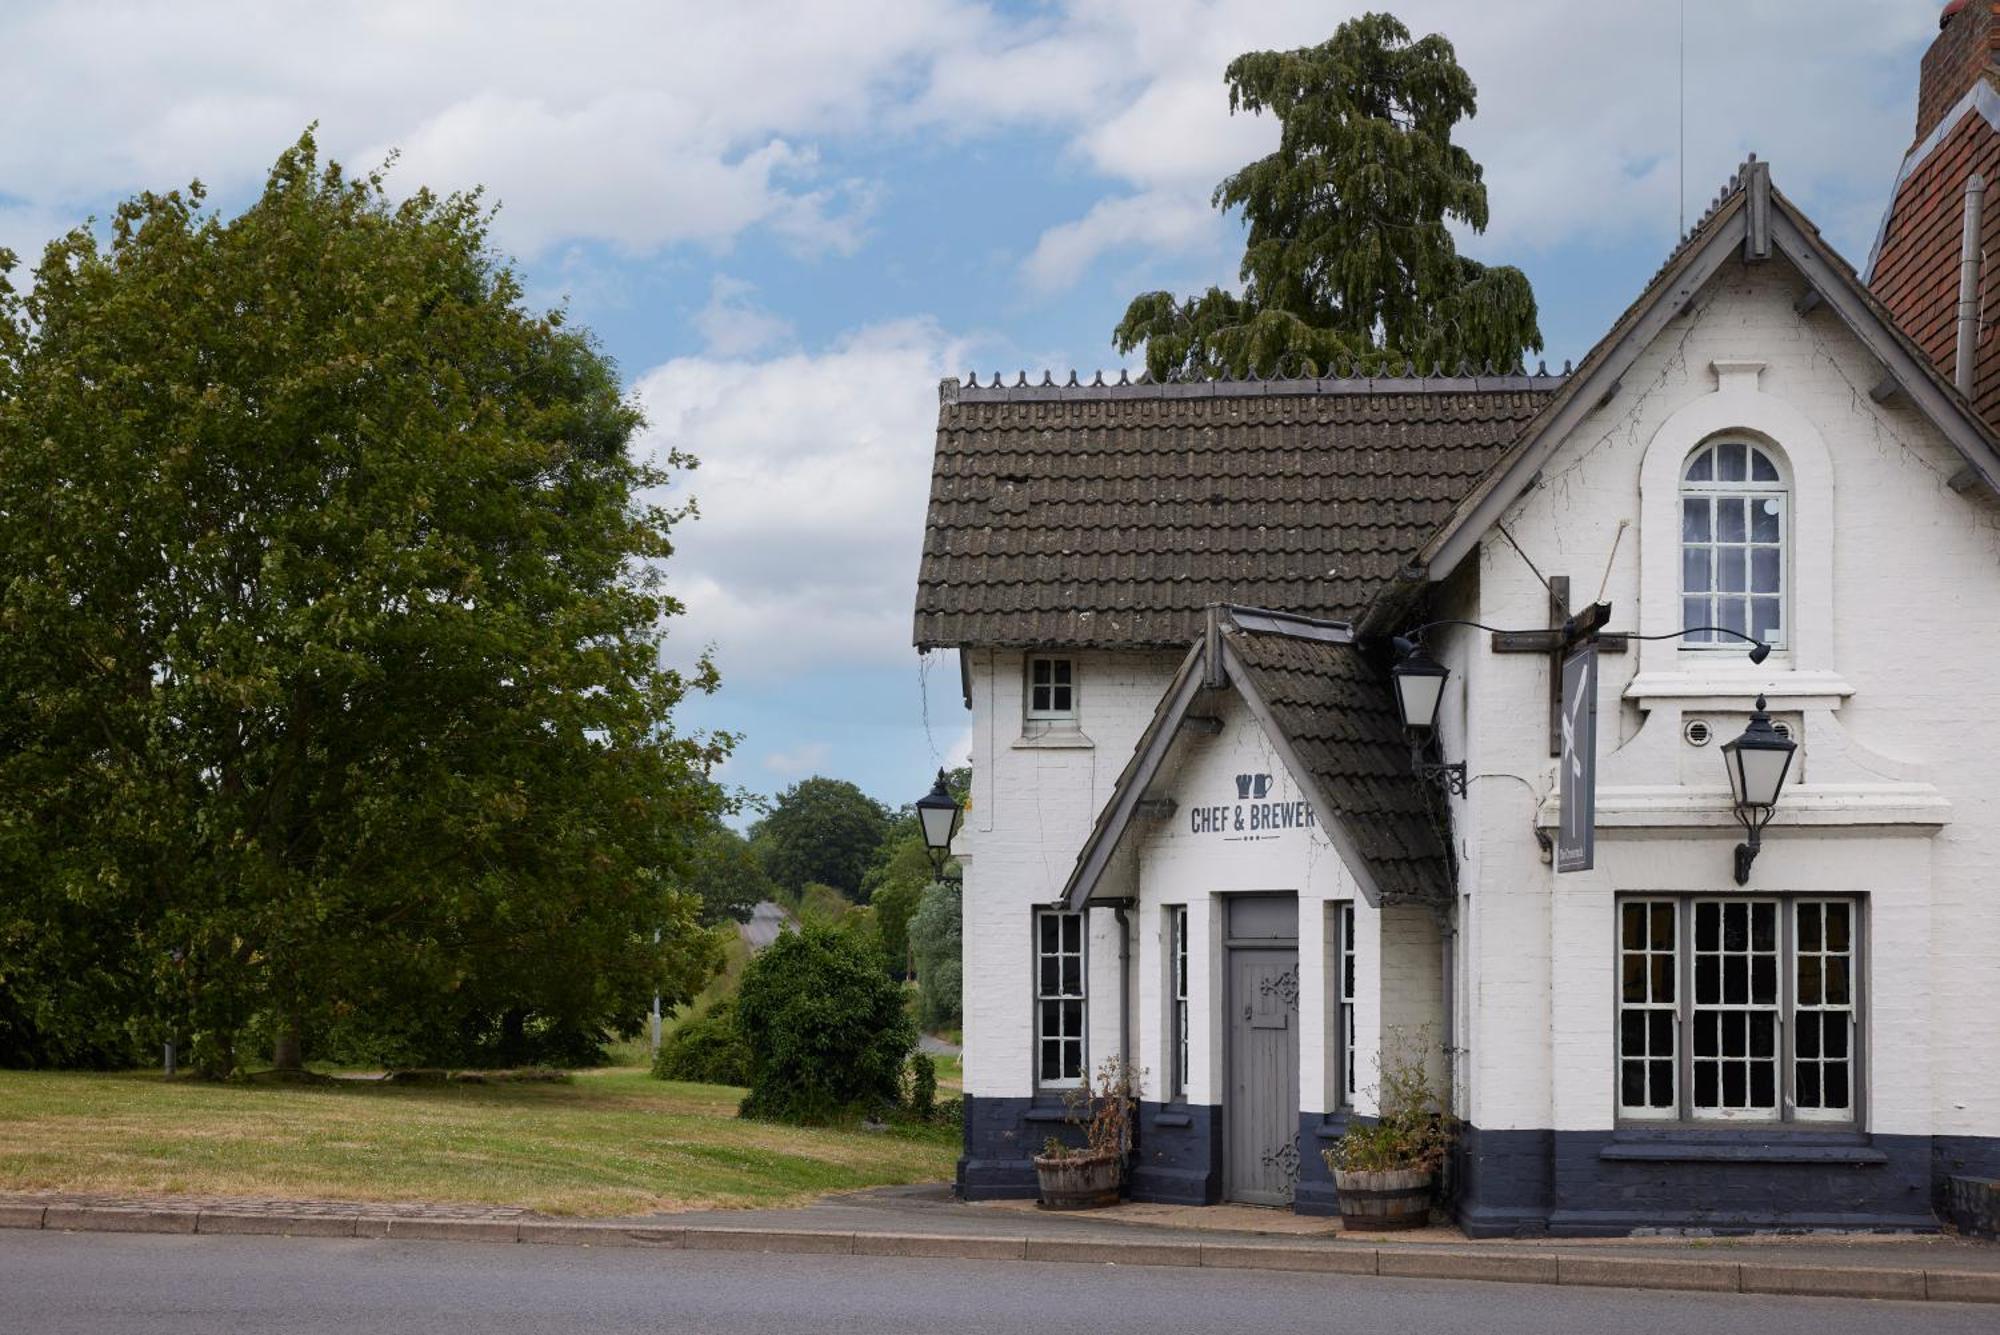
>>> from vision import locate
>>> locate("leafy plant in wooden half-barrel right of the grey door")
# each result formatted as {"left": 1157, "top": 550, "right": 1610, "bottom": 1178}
{"left": 1324, "top": 1041, "right": 1458, "bottom": 1233}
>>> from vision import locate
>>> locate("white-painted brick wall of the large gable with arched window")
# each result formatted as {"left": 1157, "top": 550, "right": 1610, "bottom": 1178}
{"left": 1452, "top": 260, "right": 2000, "bottom": 1135}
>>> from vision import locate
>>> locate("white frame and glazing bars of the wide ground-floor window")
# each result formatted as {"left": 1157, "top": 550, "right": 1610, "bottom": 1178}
{"left": 1612, "top": 895, "right": 1866, "bottom": 1127}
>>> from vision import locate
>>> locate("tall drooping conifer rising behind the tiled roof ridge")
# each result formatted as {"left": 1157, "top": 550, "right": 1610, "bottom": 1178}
{"left": 1112, "top": 14, "right": 1542, "bottom": 380}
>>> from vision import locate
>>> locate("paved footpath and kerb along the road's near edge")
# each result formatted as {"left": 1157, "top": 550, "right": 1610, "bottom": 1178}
{"left": 0, "top": 1185, "right": 2000, "bottom": 1303}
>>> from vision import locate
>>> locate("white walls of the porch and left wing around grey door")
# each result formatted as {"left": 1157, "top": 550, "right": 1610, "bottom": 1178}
{"left": 958, "top": 654, "right": 1442, "bottom": 1111}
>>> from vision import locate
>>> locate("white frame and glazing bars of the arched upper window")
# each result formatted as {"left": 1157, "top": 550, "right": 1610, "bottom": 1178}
{"left": 1676, "top": 443, "right": 1792, "bottom": 654}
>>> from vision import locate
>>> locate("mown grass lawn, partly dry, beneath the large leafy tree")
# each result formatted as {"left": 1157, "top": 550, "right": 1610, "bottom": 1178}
{"left": 0, "top": 1067, "right": 958, "bottom": 1215}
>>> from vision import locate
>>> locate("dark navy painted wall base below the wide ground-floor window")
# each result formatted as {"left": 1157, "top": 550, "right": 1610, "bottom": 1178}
{"left": 1458, "top": 1127, "right": 2000, "bottom": 1237}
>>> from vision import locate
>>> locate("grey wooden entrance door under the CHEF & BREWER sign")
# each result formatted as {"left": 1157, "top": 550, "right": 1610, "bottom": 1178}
{"left": 1222, "top": 947, "right": 1298, "bottom": 1205}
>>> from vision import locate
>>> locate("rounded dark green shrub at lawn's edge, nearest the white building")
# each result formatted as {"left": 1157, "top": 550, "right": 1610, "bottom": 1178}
{"left": 736, "top": 923, "right": 916, "bottom": 1123}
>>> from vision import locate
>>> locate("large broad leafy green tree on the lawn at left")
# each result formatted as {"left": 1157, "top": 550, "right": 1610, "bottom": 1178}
{"left": 0, "top": 134, "right": 728, "bottom": 1073}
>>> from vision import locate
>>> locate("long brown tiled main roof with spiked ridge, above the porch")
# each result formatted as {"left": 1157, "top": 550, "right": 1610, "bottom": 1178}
{"left": 916, "top": 374, "right": 1562, "bottom": 650}
